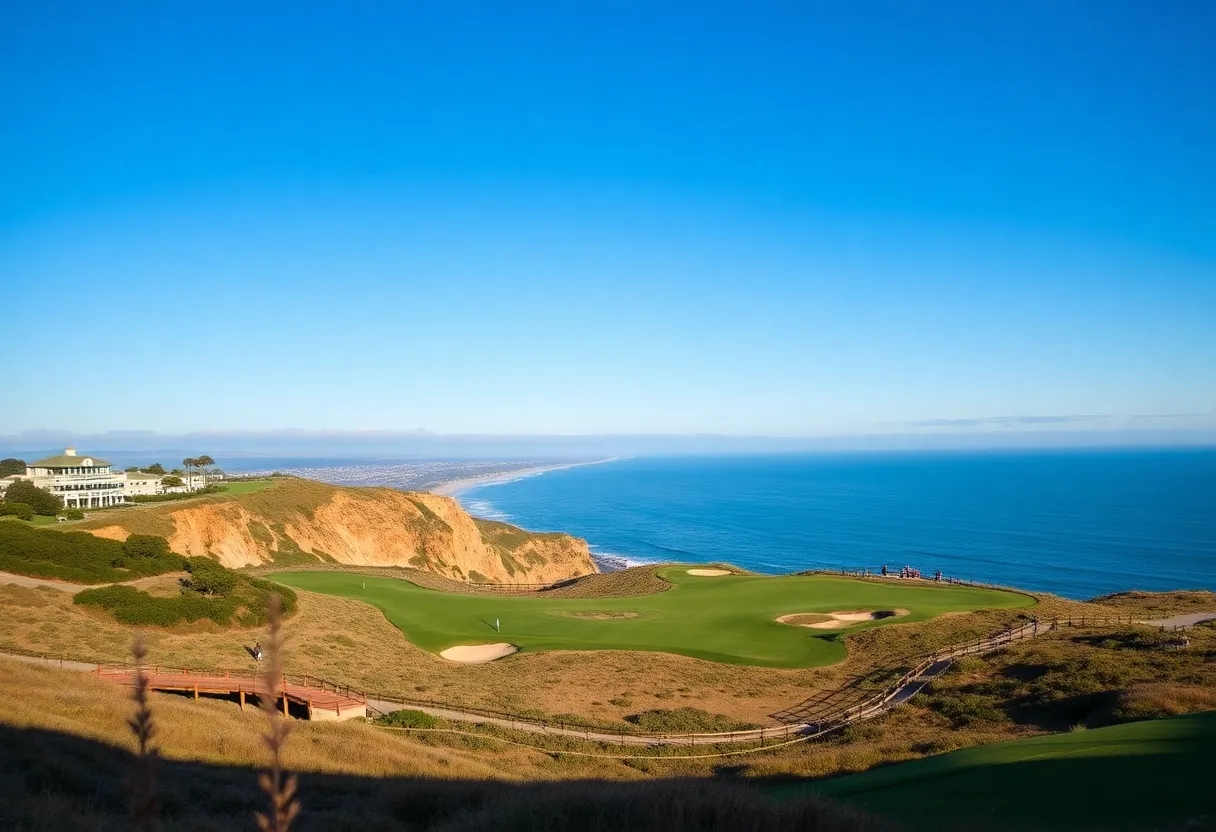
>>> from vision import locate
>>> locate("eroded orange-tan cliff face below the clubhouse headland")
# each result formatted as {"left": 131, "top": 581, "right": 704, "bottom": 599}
{"left": 84, "top": 479, "right": 596, "bottom": 583}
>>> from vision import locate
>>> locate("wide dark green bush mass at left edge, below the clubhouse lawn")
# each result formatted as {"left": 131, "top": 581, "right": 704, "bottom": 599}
{"left": 0, "top": 523, "right": 182, "bottom": 584}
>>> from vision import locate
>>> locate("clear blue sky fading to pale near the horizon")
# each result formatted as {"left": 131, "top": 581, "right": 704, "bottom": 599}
{"left": 0, "top": 0, "right": 1216, "bottom": 435}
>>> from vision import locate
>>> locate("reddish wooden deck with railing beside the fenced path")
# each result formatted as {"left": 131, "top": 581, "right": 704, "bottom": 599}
{"left": 97, "top": 668, "right": 367, "bottom": 720}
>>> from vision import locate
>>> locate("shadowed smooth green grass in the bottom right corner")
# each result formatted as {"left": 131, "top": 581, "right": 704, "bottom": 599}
{"left": 775, "top": 712, "right": 1216, "bottom": 830}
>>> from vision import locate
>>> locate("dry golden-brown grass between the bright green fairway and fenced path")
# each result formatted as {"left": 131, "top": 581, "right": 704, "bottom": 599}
{"left": 0, "top": 571, "right": 1108, "bottom": 725}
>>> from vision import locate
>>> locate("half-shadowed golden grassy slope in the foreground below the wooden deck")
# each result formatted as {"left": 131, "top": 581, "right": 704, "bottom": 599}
{"left": 0, "top": 659, "right": 885, "bottom": 832}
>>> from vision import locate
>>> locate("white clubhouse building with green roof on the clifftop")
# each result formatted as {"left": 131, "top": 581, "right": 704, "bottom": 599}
{"left": 10, "top": 448, "right": 206, "bottom": 508}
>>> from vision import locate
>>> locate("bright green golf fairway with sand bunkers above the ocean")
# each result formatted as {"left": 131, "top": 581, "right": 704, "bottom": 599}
{"left": 271, "top": 567, "right": 1035, "bottom": 668}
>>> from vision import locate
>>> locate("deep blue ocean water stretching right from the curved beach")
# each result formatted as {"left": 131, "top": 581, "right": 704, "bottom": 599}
{"left": 460, "top": 450, "right": 1216, "bottom": 598}
